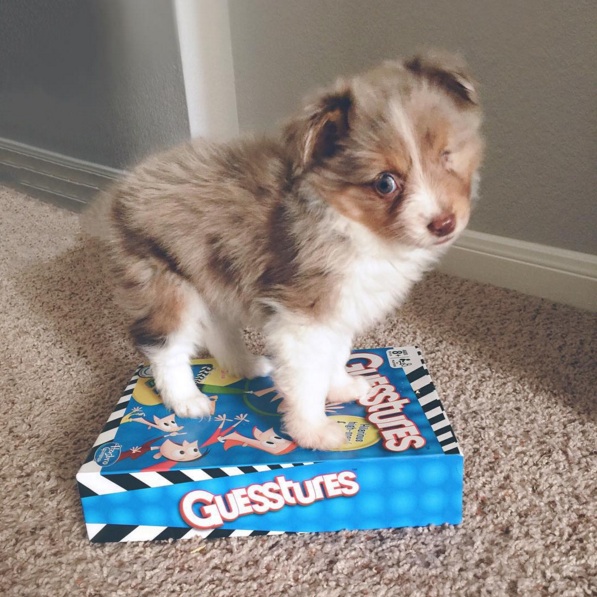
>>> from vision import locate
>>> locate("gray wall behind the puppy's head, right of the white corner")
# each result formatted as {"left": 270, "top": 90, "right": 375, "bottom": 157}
{"left": 230, "top": 0, "right": 597, "bottom": 254}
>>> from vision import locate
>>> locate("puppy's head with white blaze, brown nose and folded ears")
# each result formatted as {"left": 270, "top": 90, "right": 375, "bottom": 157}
{"left": 284, "top": 50, "right": 483, "bottom": 247}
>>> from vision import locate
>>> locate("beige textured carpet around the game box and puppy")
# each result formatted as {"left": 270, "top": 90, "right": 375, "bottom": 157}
{"left": 0, "top": 188, "right": 597, "bottom": 597}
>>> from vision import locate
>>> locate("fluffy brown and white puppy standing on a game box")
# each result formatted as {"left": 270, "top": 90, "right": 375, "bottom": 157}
{"left": 98, "top": 55, "right": 483, "bottom": 450}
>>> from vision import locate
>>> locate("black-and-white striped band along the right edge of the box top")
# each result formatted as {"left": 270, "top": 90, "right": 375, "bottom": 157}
{"left": 404, "top": 346, "right": 462, "bottom": 455}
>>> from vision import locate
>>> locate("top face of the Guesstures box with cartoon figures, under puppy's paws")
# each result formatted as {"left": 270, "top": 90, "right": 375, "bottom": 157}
{"left": 79, "top": 346, "right": 461, "bottom": 474}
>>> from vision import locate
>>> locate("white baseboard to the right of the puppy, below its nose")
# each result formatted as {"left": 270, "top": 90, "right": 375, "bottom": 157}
{"left": 439, "top": 230, "right": 597, "bottom": 312}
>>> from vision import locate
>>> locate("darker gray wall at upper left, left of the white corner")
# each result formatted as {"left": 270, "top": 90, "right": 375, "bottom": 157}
{"left": 0, "top": 0, "right": 189, "bottom": 168}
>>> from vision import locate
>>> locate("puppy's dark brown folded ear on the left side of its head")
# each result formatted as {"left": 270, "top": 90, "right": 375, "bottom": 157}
{"left": 284, "top": 86, "right": 354, "bottom": 170}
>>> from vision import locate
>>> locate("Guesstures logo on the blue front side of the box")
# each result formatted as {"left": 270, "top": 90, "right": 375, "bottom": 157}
{"left": 179, "top": 471, "right": 360, "bottom": 530}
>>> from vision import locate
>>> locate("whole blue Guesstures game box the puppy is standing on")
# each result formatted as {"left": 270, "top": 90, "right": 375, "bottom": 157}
{"left": 77, "top": 347, "right": 463, "bottom": 542}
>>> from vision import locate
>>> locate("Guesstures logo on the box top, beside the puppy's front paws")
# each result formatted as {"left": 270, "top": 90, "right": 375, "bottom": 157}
{"left": 346, "top": 352, "right": 426, "bottom": 452}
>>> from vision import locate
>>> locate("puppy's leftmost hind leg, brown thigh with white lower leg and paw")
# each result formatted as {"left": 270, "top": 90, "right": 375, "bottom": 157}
{"left": 131, "top": 272, "right": 211, "bottom": 418}
